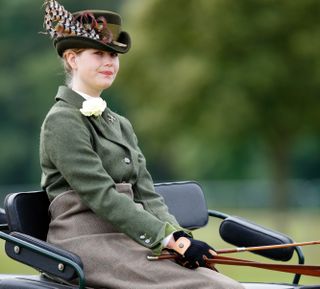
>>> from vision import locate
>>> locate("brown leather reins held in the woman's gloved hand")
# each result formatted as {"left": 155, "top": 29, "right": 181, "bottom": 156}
{"left": 147, "top": 241, "right": 320, "bottom": 276}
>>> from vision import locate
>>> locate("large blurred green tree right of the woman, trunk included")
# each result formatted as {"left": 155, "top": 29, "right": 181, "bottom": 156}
{"left": 120, "top": 0, "right": 320, "bottom": 209}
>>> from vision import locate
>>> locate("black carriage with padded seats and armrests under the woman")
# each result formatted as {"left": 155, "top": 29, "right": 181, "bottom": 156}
{"left": 0, "top": 181, "right": 320, "bottom": 289}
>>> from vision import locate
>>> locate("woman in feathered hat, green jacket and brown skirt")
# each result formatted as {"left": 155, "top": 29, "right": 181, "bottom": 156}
{"left": 40, "top": 0, "right": 242, "bottom": 289}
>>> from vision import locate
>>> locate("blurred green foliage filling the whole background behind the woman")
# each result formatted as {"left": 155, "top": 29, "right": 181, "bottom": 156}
{"left": 0, "top": 0, "right": 320, "bottom": 282}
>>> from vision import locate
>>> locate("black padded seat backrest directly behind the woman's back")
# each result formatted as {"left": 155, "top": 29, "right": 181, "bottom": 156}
{"left": 4, "top": 191, "right": 50, "bottom": 241}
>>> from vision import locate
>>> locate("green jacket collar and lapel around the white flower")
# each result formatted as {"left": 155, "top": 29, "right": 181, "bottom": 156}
{"left": 56, "top": 86, "right": 128, "bottom": 148}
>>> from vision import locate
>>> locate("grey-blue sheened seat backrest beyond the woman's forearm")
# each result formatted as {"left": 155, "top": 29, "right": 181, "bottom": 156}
{"left": 155, "top": 181, "right": 208, "bottom": 229}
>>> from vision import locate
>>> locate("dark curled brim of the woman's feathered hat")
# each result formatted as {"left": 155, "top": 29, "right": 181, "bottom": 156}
{"left": 54, "top": 31, "right": 131, "bottom": 56}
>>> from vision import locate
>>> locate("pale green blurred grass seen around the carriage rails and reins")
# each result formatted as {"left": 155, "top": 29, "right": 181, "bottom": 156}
{"left": 0, "top": 210, "right": 320, "bottom": 285}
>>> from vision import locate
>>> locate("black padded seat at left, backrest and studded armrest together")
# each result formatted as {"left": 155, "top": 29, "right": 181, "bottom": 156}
{"left": 1, "top": 190, "right": 84, "bottom": 283}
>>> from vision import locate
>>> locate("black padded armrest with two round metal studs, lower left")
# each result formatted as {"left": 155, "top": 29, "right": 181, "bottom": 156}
{"left": 0, "top": 232, "right": 84, "bottom": 282}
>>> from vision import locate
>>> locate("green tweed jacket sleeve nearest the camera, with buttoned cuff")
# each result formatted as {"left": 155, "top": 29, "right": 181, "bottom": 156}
{"left": 40, "top": 107, "right": 174, "bottom": 249}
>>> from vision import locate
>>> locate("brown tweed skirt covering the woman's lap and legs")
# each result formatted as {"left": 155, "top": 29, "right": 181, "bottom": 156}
{"left": 47, "top": 187, "right": 243, "bottom": 289}
